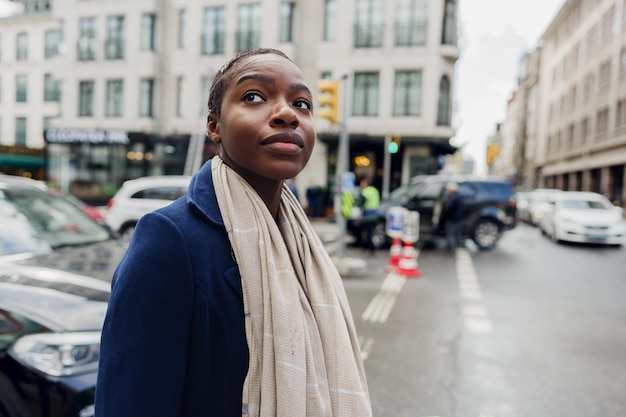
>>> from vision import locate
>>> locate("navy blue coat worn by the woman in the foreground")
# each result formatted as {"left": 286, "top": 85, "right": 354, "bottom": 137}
{"left": 95, "top": 158, "right": 248, "bottom": 417}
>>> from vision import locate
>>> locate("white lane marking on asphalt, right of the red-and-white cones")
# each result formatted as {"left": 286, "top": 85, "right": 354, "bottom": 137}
{"left": 456, "top": 249, "right": 493, "bottom": 334}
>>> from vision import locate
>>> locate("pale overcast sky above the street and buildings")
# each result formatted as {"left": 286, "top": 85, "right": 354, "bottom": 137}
{"left": 0, "top": 0, "right": 565, "bottom": 173}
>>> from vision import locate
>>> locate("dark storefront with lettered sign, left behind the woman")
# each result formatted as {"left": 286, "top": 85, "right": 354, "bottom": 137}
{"left": 44, "top": 129, "right": 215, "bottom": 203}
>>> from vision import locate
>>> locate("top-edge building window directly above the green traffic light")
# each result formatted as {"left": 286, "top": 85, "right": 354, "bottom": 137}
{"left": 395, "top": 0, "right": 428, "bottom": 46}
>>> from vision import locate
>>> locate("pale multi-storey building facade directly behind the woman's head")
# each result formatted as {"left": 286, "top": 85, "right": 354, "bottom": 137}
{"left": 0, "top": 0, "right": 459, "bottom": 204}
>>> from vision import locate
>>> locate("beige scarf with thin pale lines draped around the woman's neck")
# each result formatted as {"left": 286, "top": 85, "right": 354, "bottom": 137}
{"left": 212, "top": 156, "right": 372, "bottom": 417}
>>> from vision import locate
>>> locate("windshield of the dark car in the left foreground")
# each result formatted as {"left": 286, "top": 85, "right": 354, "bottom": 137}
{"left": 0, "top": 189, "right": 109, "bottom": 256}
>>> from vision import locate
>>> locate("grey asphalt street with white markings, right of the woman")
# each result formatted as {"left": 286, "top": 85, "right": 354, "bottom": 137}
{"left": 326, "top": 224, "right": 626, "bottom": 417}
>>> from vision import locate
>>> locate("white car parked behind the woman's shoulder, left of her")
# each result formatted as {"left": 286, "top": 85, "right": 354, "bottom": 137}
{"left": 106, "top": 175, "right": 191, "bottom": 239}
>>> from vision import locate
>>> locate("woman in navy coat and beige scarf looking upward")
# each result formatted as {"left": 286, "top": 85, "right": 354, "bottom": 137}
{"left": 95, "top": 49, "right": 372, "bottom": 417}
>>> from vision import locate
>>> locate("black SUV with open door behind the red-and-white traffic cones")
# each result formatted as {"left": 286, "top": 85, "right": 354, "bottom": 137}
{"left": 348, "top": 175, "right": 517, "bottom": 249}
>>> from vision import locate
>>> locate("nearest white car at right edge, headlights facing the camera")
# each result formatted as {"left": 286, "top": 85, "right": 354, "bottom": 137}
{"left": 539, "top": 191, "right": 626, "bottom": 246}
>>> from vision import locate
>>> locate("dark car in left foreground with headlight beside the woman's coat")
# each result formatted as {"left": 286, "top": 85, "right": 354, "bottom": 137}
{"left": 0, "top": 175, "right": 126, "bottom": 417}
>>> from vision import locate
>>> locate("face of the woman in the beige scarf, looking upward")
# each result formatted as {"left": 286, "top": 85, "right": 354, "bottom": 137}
{"left": 208, "top": 54, "right": 315, "bottom": 186}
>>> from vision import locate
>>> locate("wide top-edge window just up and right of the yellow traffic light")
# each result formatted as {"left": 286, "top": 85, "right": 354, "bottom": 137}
{"left": 354, "top": 0, "right": 385, "bottom": 48}
